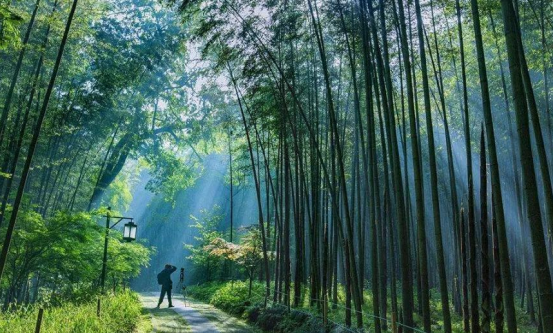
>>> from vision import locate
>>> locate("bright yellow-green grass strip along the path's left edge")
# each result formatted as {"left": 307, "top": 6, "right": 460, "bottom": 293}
{"left": 0, "top": 292, "right": 142, "bottom": 333}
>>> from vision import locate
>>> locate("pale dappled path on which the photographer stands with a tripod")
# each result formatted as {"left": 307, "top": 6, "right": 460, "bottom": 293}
{"left": 140, "top": 292, "right": 254, "bottom": 333}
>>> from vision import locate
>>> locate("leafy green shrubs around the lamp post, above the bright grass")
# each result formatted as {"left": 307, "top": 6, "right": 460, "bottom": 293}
{"left": 3, "top": 210, "right": 152, "bottom": 304}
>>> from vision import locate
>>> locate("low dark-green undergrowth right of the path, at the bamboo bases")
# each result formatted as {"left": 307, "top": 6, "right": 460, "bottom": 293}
{"left": 187, "top": 280, "right": 533, "bottom": 333}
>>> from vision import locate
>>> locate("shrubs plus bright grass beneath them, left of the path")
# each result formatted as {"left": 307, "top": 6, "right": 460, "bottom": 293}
{"left": 0, "top": 209, "right": 153, "bottom": 333}
